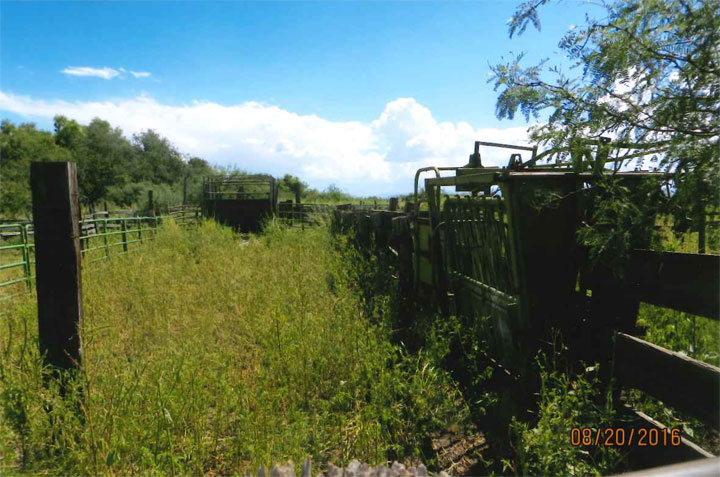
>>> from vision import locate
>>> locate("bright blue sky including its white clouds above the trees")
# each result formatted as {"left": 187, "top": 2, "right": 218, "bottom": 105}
{"left": 0, "top": 1, "right": 591, "bottom": 194}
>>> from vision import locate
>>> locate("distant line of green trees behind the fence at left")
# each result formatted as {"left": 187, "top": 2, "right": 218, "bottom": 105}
{"left": 0, "top": 116, "right": 396, "bottom": 218}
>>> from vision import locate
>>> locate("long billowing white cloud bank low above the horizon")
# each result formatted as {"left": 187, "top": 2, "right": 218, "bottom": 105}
{"left": 0, "top": 92, "right": 527, "bottom": 195}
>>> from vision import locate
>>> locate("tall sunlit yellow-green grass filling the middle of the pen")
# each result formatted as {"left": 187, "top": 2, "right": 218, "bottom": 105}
{"left": 0, "top": 222, "right": 467, "bottom": 474}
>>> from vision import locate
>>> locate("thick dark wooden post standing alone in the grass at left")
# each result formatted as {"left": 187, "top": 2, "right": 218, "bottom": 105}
{"left": 30, "top": 162, "right": 83, "bottom": 370}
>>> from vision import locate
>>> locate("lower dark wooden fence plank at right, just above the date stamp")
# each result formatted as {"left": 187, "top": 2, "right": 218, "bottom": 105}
{"left": 615, "top": 333, "right": 720, "bottom": 429}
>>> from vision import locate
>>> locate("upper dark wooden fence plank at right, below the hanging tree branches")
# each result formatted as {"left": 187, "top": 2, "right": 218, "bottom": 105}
{"left": 623, "top": 250, "right": 720, "bottom": 320}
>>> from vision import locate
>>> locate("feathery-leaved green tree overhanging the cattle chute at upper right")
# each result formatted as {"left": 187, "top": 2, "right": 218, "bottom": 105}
{"left": 490, "top": 0, "right": 720, "bottom": 256}
